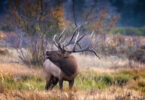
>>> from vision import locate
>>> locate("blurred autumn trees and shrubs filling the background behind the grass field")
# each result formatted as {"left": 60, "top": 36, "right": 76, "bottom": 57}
{"left": 0, "top": 0, "right": 145, "bottom": 65}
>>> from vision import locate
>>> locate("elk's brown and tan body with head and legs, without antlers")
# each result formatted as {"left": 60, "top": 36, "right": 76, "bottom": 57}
{"left": 44, "top": 51, "right": 78, "bottom": 90}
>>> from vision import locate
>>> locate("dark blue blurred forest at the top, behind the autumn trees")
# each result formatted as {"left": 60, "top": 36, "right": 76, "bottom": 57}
{"left": 0, "top": 0, "right": 145, "bottom": 27}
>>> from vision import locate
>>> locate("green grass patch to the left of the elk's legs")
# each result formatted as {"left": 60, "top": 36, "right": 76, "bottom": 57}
{"left": 0, "top": 75, "right": 45, "bottom": 90}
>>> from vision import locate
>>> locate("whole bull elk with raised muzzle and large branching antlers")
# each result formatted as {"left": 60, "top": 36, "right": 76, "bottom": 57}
{"left": 44, "top": 28, "right": 98, "bottom": 90}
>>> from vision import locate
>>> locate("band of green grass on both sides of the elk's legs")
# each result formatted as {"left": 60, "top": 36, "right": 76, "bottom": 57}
{"left": 0, "top": 70, "right": 145, "bottom": 90}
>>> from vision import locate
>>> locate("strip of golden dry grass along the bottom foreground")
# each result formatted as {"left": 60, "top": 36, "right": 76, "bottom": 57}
{"left": 0, "top": 87, "right": 144, "bottom": 100}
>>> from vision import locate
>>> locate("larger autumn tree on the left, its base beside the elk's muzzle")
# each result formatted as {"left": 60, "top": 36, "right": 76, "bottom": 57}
{"left": 8, "top": 0, "right": 65, "bottom": 65}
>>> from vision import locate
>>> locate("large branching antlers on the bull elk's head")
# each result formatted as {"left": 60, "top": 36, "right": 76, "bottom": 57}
{"left": 53, "top": 26, "right": 100, "bottom": 59}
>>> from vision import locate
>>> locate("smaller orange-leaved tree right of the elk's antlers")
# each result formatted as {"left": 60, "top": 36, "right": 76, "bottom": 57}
{"left": 84, "top": 8, "right": 119, "bottom": 52}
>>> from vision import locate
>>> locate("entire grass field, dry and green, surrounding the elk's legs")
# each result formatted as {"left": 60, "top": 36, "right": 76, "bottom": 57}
{"left": 0, "top": 50, "right": 145, "bottom": 100}
